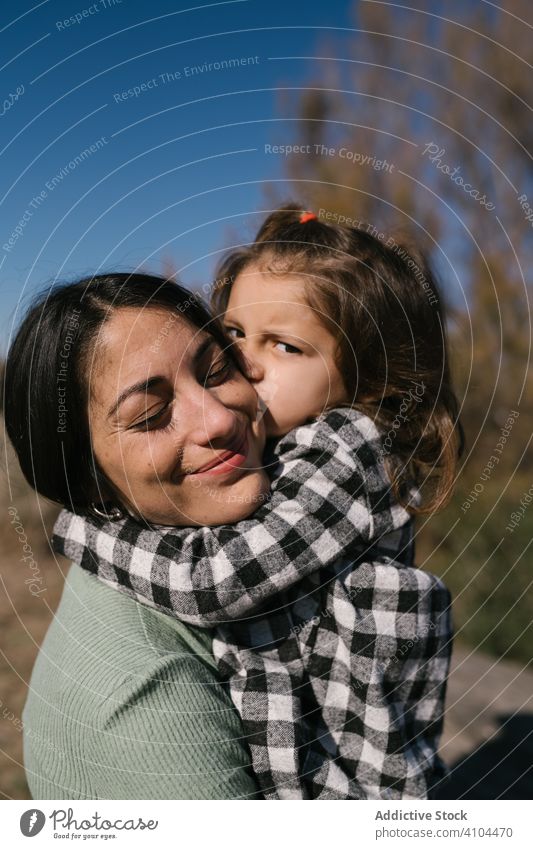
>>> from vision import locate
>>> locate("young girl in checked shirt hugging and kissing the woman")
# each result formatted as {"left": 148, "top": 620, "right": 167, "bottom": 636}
{"left": 54, "top": 206, "right": 462, "bottom": 799}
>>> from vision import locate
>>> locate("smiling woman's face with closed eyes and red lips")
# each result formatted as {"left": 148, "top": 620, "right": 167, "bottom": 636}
{"left": 88, "top": 308, "right": 269, "bottom": 525}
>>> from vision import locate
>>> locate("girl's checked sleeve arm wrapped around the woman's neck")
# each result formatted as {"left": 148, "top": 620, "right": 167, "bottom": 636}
{"left": 54, "top": 408, "right": 408, "bottom": 627}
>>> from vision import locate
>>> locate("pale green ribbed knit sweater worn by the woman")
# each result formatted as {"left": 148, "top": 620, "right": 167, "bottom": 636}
{"left": 23, "top": 566, "right": 257, "bottom": 799}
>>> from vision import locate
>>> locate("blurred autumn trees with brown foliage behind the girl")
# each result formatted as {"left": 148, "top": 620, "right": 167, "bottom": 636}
{"left": 268, "top": 0, "right": 533, "bottom": 663}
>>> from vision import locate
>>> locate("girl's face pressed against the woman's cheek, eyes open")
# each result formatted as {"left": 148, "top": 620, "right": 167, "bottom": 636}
{"left": 224, "top": 266, "right": 347, "bottom": 436}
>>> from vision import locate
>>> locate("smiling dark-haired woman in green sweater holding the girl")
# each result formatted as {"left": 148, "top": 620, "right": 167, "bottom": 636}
{"left": 5, "top": 274, "right": 269, "bottom": 799}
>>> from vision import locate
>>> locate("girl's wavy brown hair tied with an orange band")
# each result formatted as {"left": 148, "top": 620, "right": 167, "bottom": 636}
{"left": 211, "top": 203, "right": 464, "bottom": 514}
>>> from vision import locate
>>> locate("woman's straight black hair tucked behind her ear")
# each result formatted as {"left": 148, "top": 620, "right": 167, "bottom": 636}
{"left": 4, "top": 274, "right": 233, "bottom": 512}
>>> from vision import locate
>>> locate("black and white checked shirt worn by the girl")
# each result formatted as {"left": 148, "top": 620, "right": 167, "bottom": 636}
{"left": 54, "top": 408, "right": 452, "bottom": 799}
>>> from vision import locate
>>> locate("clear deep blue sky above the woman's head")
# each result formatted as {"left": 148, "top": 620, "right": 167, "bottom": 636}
{"left": 0, "top": 0, "right": 362, "bottom": 350}
